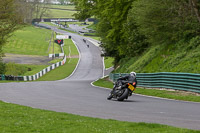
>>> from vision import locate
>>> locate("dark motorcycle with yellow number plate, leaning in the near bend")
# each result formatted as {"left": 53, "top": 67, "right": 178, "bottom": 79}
{"left": 107, "top": 81, "right": 136, "bottom": 101}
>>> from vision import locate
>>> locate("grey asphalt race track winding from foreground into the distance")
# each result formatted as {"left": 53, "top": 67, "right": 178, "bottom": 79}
{"left": 0, "top": 24, "right": 200, "bottom": 130}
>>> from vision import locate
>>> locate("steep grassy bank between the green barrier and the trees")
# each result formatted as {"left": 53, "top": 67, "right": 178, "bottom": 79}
{"left": 115, "top": 37, "right": 200, "bottom": 73}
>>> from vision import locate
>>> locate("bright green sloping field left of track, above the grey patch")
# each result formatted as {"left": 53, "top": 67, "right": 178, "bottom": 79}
{"left": 3, "top": 26, "right": 51, "bottom": 56}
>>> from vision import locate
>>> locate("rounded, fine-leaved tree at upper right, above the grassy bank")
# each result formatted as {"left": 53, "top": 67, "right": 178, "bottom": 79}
{"left": 130, "top": 0, "right": 200, "bottom": 45}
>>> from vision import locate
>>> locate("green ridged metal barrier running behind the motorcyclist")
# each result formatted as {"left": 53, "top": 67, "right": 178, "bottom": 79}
{"left": 110, "top": 72, "right": 200, "bottom": 93}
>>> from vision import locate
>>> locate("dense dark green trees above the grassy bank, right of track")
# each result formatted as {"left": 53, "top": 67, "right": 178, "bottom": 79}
{"left": 72, "top": 0, "right": 200, "bottom": 61}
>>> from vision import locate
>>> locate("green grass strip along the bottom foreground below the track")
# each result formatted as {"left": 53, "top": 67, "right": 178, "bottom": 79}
{"left": 0, "top": 101, "right": 199, "bottom": 133}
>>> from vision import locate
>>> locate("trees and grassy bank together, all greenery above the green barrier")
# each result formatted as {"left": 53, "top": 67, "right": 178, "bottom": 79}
{"left": 74, "top": 0, "right": 200, "bottom": 72}
